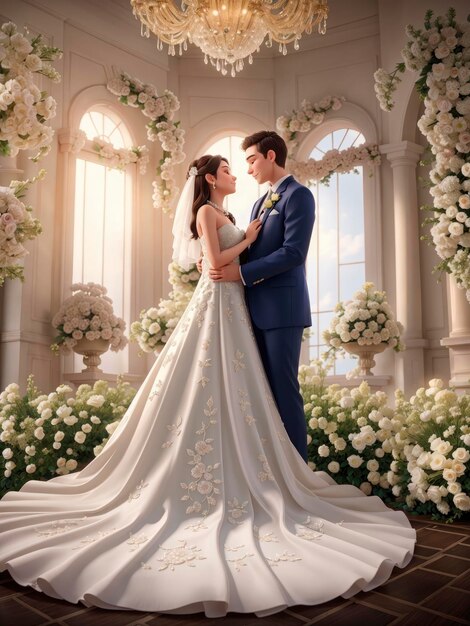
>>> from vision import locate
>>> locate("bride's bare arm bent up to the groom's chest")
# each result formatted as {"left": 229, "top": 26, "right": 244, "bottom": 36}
{"left": 197, "top": 204, "right": 261, "bottom": 267}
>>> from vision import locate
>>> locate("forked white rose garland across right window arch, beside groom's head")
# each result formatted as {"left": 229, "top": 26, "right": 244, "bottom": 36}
{"left": 276, "top": 96, "right": 380, "bottom": 185}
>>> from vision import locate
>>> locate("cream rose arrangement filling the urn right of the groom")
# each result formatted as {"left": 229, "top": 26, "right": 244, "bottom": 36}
{"left": 323, "top": 283, "right": 404, "bottom": 352}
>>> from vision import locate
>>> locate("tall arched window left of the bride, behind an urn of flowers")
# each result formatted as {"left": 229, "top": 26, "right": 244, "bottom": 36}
{"left": 72, "top": 106, "right": 135, "bottom": 374}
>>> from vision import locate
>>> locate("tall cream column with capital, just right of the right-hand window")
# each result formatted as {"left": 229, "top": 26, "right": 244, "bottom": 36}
{"left": 380, "top": 141, "right": 427, "bottom": 394}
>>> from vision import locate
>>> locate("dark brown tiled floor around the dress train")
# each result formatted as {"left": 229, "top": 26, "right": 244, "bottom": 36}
{"left": 0, "top": 517, "right": 470, "bottom": 626}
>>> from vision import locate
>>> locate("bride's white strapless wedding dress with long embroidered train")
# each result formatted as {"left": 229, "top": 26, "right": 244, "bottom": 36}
{"left": 0, "top": 224, "right": 415, "bottom": 617}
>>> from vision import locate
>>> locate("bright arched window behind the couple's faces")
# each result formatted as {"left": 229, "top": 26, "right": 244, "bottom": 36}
{"left": 201, "top": 134, "right": 264, "bottom": 228}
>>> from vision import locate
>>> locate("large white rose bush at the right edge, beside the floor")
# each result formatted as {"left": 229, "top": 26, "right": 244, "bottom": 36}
{"left": 390, "top": 379, "right": 470, "bottom": 519}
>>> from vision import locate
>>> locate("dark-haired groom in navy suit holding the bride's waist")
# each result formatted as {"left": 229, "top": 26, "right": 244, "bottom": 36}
{"left": 210, "top": 131, "right": 315, "bottom": 460}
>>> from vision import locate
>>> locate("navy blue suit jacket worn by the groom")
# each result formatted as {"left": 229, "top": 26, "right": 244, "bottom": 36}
{"left": 241, "top": 176, "right": 315, "bottom": 330}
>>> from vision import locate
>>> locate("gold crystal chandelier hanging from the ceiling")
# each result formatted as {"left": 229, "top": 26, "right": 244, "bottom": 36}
{"left": 131, "top": 0, "right": 328, "bottom": 76}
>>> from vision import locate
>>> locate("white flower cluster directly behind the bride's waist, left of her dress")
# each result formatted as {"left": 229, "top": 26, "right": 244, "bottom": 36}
{"left": 130, "top": 261, "right": 200, "bottom": 352}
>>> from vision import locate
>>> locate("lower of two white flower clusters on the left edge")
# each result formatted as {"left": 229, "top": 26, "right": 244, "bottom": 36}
{"left": 0, "top": 170, "right": 45, "bottom": 286}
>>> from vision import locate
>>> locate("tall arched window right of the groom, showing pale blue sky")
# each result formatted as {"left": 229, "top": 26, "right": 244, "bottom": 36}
{"left": 307, "top": 128, "right": 365, "bottom": 374}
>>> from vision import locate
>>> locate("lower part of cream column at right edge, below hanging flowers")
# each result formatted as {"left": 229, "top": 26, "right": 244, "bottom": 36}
{"left": 441, "top": 276, "right": 470, "bottom": 391}
